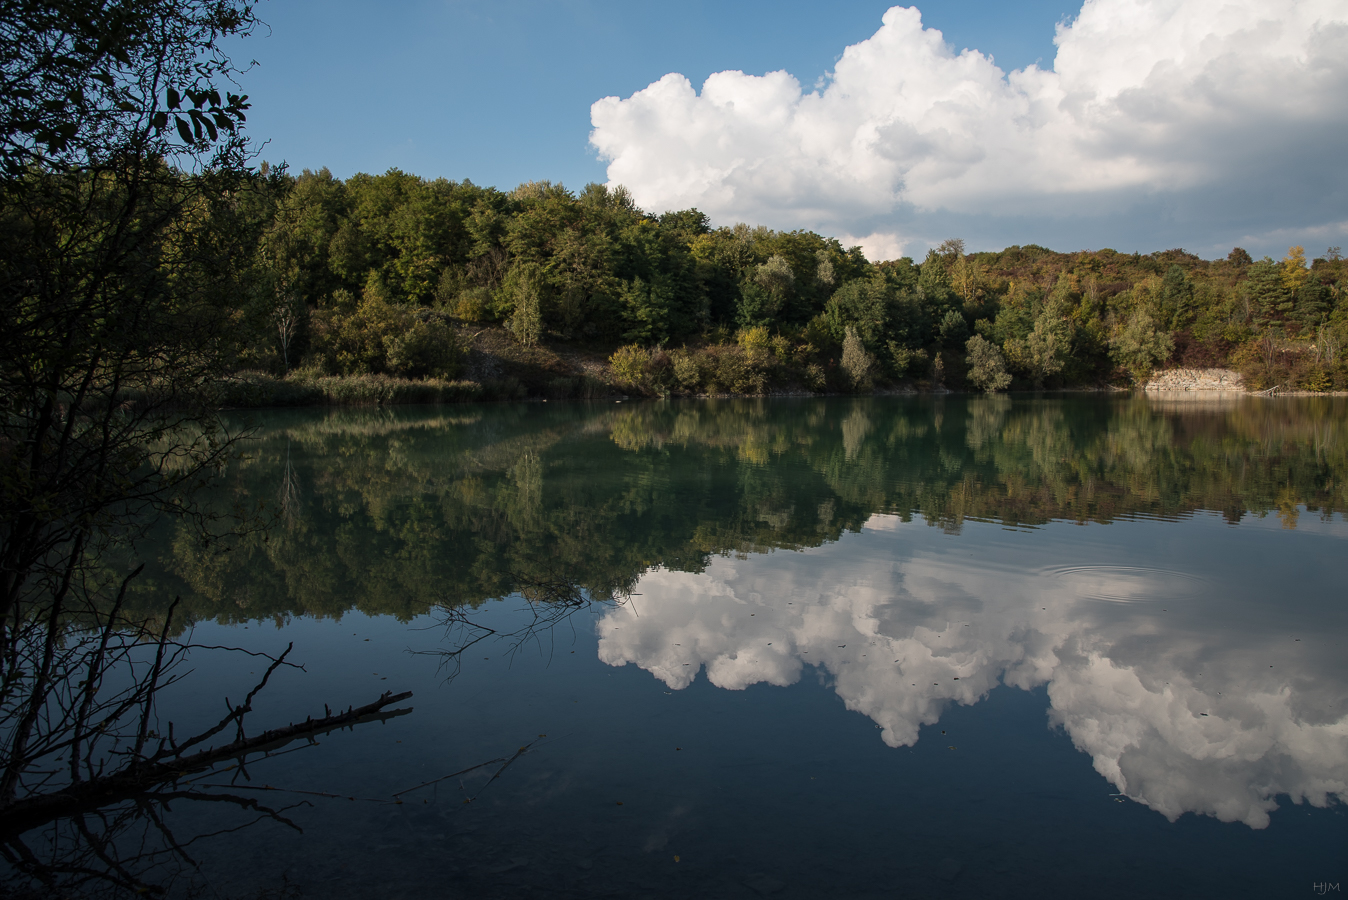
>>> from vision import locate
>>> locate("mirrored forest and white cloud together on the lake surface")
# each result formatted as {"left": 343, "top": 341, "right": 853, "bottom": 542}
{"left": 128, "top": 397, "right": 1348, "bottom": 851}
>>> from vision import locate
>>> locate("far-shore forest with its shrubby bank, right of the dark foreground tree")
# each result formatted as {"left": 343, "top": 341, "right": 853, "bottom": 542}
{"left": 199, "top": 166, "right": 1348, "bottom": 396}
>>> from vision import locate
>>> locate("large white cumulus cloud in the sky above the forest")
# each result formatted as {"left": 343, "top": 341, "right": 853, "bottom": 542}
{"left": 590, "top": 0, "right": 1348, "bottom": 255}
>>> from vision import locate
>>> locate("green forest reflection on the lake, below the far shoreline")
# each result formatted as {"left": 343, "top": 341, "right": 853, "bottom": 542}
{"left": 147, "top": 397, "right": 1348, "bottom": 633}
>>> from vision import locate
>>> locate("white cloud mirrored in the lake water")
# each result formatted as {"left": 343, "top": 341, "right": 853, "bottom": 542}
{"left": 599, "top": 516, "right": 1348, "bottom": 829}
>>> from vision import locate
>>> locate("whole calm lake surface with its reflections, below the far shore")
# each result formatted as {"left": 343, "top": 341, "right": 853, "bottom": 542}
{"left": 10, "top": 395, "right": 1348, "bottom": 900}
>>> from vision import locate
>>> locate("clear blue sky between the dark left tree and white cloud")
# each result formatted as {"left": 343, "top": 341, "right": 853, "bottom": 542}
{"left": 237, "top": 0, "right": 1077, "bottom": 189}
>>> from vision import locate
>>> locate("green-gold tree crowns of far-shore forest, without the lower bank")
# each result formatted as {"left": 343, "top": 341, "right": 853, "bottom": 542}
{"left": 207, "top": 162, "right": 1348, "bottom": 389}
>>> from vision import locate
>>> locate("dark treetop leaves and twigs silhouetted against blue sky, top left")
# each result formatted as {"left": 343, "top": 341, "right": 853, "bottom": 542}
{"left": 0, "top": 0, "right": 256, "bottom": 179}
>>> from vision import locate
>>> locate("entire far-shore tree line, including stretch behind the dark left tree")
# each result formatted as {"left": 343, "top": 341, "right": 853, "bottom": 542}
{"left": 10, "top": 149, "right": 1348, "bottom": 403}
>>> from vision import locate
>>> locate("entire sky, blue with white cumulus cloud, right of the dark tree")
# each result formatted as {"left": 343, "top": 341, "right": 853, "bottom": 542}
{"left": 231, "top": 0, "right": 1348, "bottom": 259}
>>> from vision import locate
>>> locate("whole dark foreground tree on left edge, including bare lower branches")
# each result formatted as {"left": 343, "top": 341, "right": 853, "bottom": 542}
{"left": 0, "top": 7, "right": 328, "bottom": 896}
